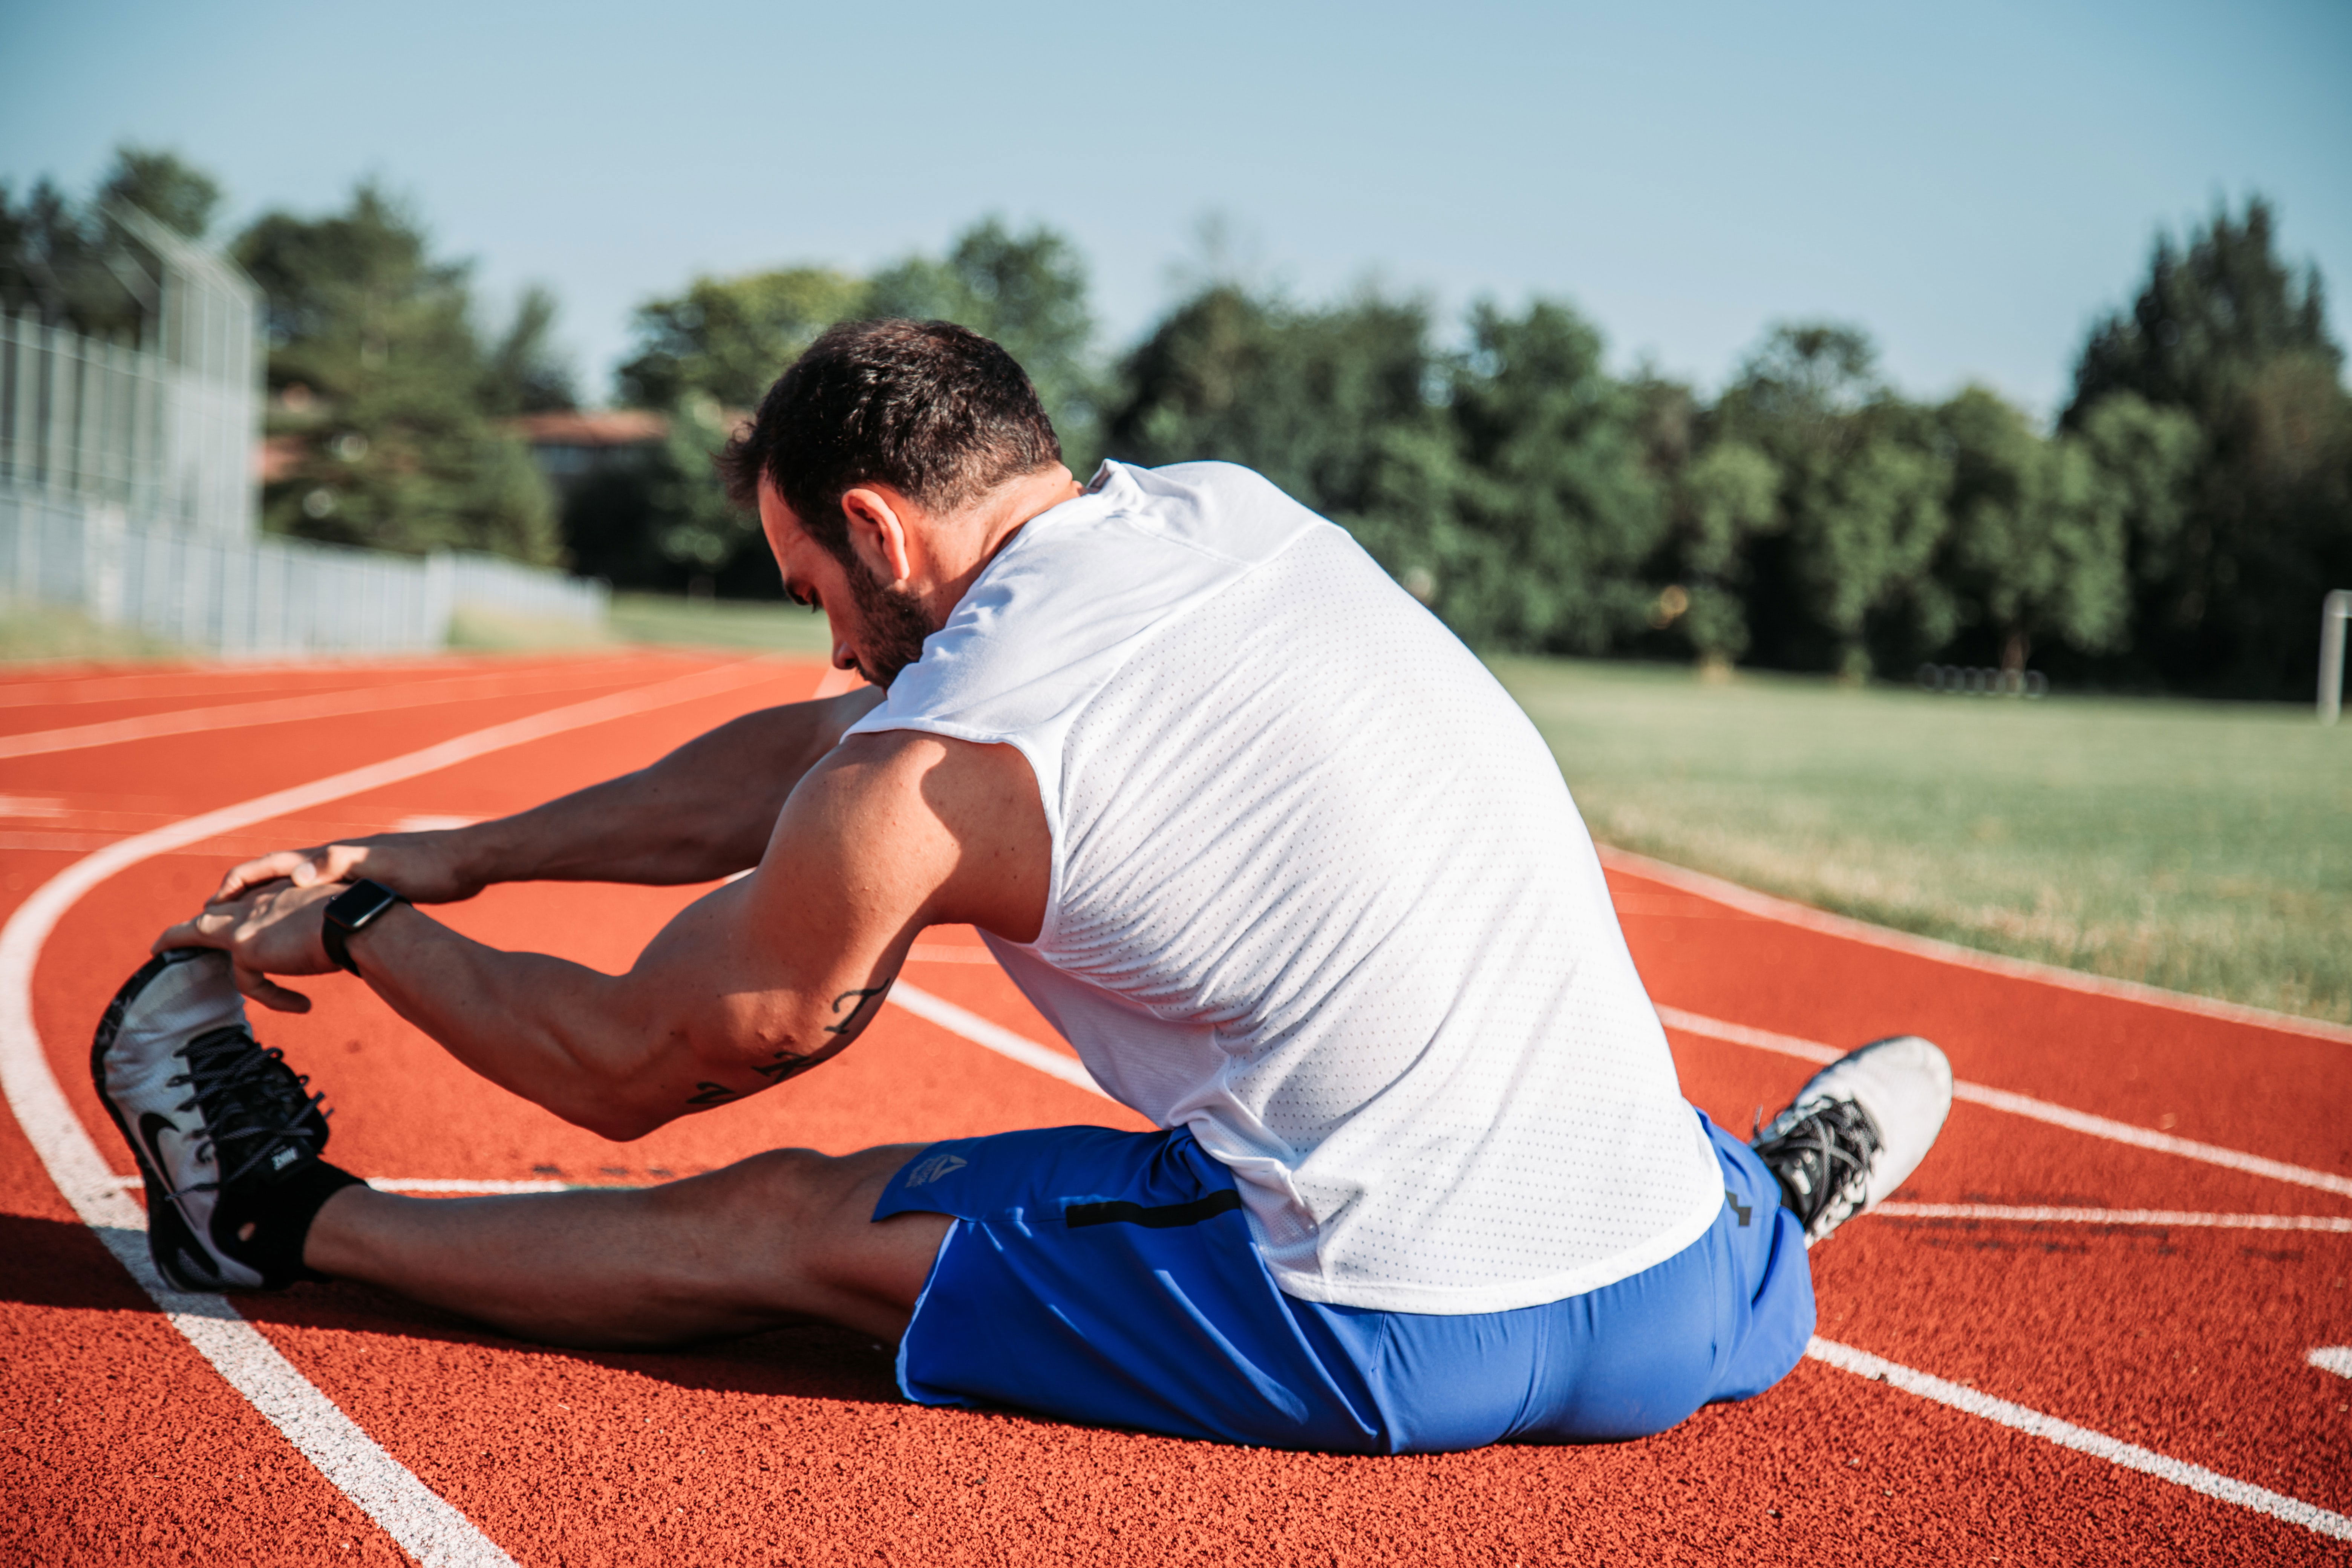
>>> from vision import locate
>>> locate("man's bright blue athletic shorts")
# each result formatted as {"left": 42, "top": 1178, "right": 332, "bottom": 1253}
{"left": 875, "top": 1112, "right": 1813, "bottom": 1453}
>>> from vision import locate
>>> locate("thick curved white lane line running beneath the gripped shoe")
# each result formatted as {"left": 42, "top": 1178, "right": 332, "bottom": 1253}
{"left": 0, "top": 661, "right": 790, "bottom": 1568}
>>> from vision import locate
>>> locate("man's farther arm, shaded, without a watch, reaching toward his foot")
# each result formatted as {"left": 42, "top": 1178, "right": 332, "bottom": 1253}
{"left": 212, "top": 689, "right": 882, "bottom": 903}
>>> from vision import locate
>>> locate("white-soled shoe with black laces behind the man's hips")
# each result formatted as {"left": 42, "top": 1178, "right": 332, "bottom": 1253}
{"left": 1752, "top": 1034, "right": 1952, "bottom": 1246}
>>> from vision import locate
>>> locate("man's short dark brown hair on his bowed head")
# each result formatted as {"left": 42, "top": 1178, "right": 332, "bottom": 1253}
{"left": 717, "top": 320, "right": 1061, "bottom": 557}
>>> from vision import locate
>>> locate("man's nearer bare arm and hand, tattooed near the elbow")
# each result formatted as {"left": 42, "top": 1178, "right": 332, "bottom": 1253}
{"left": 155, "top": 731, "right": 1051, "bottom": 1138}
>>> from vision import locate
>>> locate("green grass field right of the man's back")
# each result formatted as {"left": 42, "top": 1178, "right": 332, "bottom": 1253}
{"left": 1496, "top": 658, "right": 2352, "bottom": 1023}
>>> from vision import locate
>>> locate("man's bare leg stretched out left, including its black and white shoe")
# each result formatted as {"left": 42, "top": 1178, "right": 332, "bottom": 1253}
{"left": 89, "top": 947, "right": 948, "bottom": 1344}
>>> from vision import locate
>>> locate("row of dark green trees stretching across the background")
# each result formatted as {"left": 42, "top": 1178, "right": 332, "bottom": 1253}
{"left": 0, "top": 155, "right": 2352, "bottom": 696}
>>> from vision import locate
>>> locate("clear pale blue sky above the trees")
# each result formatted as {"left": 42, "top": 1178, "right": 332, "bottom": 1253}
{"left": 0, "top": 0, "right": 2352, "bottom": 414}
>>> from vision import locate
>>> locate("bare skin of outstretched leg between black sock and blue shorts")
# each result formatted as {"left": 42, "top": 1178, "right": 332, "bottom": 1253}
{"left": 303, "top": 1142, "right": 950, "bottom": 1347}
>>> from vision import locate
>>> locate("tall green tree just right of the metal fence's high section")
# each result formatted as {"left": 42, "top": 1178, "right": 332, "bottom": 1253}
{"left": 235, "top": 183, "right": 557, "bottom": 562}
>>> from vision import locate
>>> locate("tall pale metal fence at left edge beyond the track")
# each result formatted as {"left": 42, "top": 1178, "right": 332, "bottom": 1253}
{"left": 0, "top": 209, "right": 607, "bottom": 656}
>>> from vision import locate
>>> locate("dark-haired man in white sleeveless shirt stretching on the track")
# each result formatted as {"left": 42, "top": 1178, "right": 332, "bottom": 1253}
{"left": 94, "top": 322, "right": 1950, "bottom": 1453}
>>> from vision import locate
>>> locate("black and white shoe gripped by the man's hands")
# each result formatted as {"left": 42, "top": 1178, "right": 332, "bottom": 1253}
{"left": 89, "top": 947, "right": 357, "bottom": 1291}
